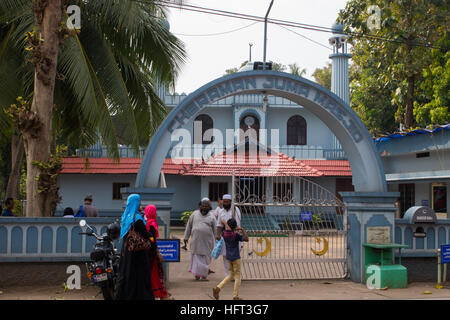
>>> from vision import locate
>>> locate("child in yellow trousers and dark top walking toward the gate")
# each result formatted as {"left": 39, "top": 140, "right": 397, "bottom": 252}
{"left": 213, "top": 218, "right": 248, "bottom": 300}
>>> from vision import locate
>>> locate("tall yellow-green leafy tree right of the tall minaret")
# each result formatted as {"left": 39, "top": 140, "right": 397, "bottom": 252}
{"left": 338, "top": 0, "right": 449, "bottom": 131}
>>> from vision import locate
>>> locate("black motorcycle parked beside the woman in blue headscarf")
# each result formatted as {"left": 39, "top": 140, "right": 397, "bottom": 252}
{"left": 79, "top": 220, "right": 120, "bottom": 300}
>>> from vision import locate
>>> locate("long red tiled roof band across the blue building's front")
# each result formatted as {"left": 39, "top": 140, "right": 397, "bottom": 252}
{"left": 61, "top": 153, "right": 352, "bottom": 177}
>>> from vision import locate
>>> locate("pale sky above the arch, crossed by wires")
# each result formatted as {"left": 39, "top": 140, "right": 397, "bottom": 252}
{"left": 169, "top": 0, "right": 347, "bottom": 94}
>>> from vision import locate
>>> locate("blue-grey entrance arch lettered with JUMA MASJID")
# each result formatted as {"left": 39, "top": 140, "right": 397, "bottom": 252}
{"left": 135, "top": 70, "right": 386, "bottom": 192}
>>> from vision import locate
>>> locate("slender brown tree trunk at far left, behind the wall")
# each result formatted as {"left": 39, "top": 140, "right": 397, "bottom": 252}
{"left": 6, "top": 134, "right": 24, "bottom": 199}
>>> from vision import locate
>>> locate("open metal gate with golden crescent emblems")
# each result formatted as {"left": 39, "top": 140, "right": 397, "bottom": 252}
{"left": 232, "top": 169, "right": 347, "bottom": 280}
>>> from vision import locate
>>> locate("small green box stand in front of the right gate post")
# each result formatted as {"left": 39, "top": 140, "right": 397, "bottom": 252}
{"left": 363, "top": 243, "right": 409, "bottom": 289}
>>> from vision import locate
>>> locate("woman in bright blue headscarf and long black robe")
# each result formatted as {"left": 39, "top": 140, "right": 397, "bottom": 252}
{"left": 116, "top": 194, "right": 155, "bottom": 300}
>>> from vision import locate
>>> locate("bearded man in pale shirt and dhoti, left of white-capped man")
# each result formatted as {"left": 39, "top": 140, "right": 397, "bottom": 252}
{"left": 184, "top": 199, "right": 216, "bottom": 280}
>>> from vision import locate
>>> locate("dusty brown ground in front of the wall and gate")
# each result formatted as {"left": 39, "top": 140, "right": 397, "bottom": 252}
{"left": 0, "top": 230, "right": 450, "bottom": 300}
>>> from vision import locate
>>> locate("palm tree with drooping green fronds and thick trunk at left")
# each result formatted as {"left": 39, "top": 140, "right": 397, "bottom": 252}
{"left": 0, "top": 0, "right": 185, "bottom": 216}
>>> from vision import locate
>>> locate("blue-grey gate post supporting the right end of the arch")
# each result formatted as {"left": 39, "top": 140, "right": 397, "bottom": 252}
{"left": 340, "top": 192, "right": 400, "bottom": 283}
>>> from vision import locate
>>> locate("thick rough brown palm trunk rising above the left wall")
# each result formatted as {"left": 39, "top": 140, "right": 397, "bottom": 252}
{"left": 23, "top": 0, "right": 62, "bottom": 217}
